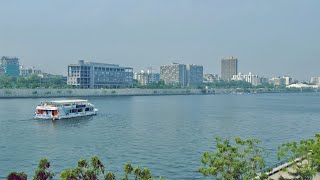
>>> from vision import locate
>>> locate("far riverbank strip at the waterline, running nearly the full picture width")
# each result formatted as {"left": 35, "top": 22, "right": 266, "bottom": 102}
{"left": 0, "top": 88, "right": 316, "bottom": 99}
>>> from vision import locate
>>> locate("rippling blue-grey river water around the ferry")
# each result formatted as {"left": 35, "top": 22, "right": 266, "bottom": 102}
{"left": 0, "top": 93, "right": 320, "bottom": 179}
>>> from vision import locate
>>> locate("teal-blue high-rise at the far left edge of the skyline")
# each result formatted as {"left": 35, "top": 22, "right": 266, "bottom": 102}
{"left": 0, "top": 56, "right": 20, "bottom": 77}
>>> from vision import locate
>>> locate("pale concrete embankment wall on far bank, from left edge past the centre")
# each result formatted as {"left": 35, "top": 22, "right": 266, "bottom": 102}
{"left": 0, "top": 88, "right": 203, "bottom": 98}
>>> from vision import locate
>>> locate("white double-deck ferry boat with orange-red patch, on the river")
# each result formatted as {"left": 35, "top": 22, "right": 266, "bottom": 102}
{"left": 34, "top": 99, "right": 98, "bottom": 120}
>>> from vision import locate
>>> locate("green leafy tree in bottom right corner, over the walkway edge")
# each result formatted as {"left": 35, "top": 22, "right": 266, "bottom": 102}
{"left": 278, "top": 134, "right": 320, "bottom": 180}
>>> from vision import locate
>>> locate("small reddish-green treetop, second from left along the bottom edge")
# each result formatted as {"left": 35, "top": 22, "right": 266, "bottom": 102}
{"left": 33, "top": 158, "right": 54, "bottom": 180}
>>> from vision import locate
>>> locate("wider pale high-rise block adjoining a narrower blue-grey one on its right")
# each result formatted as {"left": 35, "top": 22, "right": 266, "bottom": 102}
{"left": 160, "top": 63, "right": 187, "bottom": 86}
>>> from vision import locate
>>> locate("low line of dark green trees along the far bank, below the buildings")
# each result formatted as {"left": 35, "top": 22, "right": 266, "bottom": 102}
{"left": 0, "top": 74, "right": 315, "bottom": 92}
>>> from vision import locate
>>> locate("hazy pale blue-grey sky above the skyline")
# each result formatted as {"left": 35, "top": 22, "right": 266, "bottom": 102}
{"left": 0, "top": 0, "right": 320, "bottom": 79}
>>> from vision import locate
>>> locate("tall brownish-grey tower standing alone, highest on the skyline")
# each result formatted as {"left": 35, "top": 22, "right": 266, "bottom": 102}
{"left": 221, "top": 56, "right": 238, "bottom": 81}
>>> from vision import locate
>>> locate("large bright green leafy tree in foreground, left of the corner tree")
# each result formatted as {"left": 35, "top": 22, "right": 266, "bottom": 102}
{"left": 198, "top": 138, "right": 266, "bottom": 180}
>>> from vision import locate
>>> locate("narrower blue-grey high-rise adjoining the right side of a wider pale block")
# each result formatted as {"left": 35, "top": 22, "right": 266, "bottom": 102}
{"left": 186, "top": 64, "right": 203, "bottom": 86}
